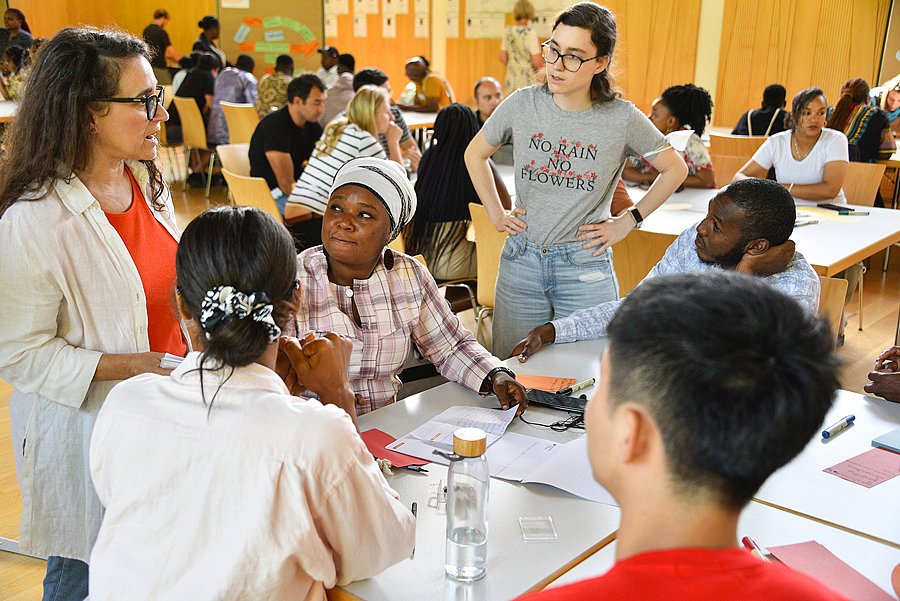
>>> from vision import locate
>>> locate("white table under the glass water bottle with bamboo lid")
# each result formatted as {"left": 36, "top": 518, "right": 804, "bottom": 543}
{"left": 329, "top": 341, "right": 620, "bottom": 601}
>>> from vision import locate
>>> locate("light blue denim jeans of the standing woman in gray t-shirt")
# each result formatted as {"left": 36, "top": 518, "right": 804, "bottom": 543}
{"left": 493, "top": 234, "right": 619, "bottom": 359}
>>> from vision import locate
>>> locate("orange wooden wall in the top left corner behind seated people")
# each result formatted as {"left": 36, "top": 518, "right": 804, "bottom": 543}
{"left": 11, "top": 0, "right": 214, "bottom": 66}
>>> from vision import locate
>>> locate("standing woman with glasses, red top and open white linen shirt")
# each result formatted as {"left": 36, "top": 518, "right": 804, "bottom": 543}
{"left": 0, "top": 28, "right": 186, "bottom": 599}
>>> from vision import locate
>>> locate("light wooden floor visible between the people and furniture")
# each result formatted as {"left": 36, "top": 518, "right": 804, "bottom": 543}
{"left": 0, "top": 166, "right": 900, "bottom": 601}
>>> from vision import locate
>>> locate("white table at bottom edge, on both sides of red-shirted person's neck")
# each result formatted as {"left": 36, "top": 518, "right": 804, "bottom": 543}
{"left": 549, "top": 502, "right": 900, "bottom": 594}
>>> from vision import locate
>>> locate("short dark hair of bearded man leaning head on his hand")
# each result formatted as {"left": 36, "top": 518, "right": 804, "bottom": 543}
{"left": 719, "top": 177, "right": 797, "bottom": 246}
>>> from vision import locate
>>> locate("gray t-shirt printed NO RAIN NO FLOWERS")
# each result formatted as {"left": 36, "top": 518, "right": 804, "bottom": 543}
{"left": 482, "top": 86, "right": 666, "bottom": 245}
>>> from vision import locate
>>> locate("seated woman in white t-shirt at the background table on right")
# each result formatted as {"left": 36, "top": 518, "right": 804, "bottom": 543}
{"left": 734, "top": 88, "right": 849, "bottom": 204}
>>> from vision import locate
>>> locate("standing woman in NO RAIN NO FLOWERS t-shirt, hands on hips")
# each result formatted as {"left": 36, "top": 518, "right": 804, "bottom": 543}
{"left": 466, "top": 2, "right": 687, "bottom": 357}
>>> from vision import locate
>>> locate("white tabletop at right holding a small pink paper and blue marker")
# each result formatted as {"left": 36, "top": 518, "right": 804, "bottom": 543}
{"left": 756, "top": 390, "right": 900, "bottom": 549}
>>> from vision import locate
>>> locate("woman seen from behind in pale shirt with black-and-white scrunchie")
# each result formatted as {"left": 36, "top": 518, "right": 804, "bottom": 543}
{"left": 89, "top": 207, "right": 415, "bottom": 600}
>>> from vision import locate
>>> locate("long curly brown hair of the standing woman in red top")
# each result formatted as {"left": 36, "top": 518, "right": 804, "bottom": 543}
{"left": 0, "top": 27, "right": 165, "bottom": 217}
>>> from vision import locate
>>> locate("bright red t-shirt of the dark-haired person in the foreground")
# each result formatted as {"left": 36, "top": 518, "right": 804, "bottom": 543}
{"left": 522, "top": 547, "right": 846, "bottom": 601}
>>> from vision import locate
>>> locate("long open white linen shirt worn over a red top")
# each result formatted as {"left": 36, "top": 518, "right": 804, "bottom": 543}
{"left": 0, "top": 161, "right": 179, "bottom": 562}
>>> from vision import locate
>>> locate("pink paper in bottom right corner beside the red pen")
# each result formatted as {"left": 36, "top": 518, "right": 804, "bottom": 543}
{"left": 768, "top": 541, "right": 894, "bottom": 601}
